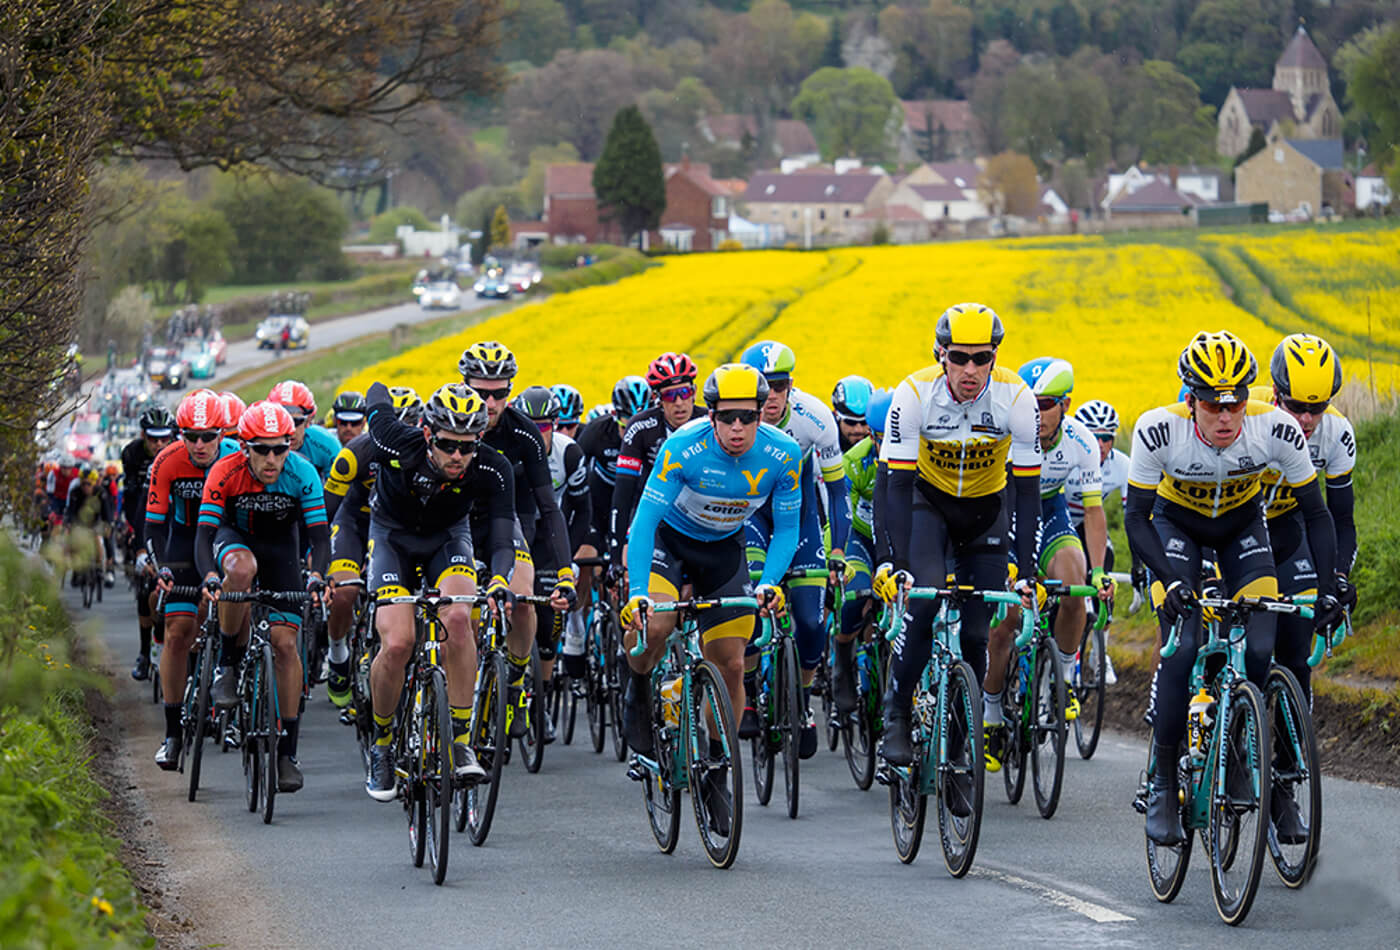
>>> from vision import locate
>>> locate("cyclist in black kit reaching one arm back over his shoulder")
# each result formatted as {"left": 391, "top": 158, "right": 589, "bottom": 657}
{"left": 365, "top": 382, "right": 515, "bottom": 802}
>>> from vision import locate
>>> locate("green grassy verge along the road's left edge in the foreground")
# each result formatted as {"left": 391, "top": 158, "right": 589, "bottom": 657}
{"left": 0, "top": 533, "right": 154, "bottom": 949}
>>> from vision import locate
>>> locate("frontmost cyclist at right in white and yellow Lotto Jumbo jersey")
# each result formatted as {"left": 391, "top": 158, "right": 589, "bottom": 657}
{"left": 1123, "top": 330, "right": 1341, "bottom": 845}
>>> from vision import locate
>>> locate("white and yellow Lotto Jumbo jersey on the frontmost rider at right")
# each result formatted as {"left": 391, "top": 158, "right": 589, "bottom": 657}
{"left": 1128, "top": 400, "right": 1317, "bottom": 518}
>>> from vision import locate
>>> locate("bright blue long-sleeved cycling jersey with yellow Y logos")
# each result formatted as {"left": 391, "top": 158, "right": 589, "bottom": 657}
{"left": 627, "top": 418, "right": 802, "bottom": 597}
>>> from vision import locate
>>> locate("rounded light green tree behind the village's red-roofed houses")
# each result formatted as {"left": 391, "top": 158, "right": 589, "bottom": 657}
{"left": 791, "top": 67, "right": 899, "bottom": 161}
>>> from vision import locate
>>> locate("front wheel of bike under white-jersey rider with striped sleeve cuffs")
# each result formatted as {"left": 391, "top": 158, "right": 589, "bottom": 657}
{"left": 924, "top": 660, "right": 986, "bottom": 877}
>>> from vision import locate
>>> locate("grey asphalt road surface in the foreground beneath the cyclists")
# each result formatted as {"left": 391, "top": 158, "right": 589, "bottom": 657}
{"left": 77, "top": 588, "right": 1400, "bottom": 950}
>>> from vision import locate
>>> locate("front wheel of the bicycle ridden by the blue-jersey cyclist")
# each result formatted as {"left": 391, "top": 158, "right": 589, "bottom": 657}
{"left": 680, "top": 660, "right": 743, "bottom": 869}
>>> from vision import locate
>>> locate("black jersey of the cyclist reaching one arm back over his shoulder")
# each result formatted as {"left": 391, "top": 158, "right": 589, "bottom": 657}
{"left": 365, "top": 382, "right": 518, "bottom": 576}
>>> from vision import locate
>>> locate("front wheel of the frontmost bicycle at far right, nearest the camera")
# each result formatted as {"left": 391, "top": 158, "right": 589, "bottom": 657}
{"left": 1207, "top": 683, "right": 1273, "bottom": 926}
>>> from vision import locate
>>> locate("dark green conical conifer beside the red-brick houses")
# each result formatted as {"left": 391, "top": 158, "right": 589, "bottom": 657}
{"left": 594, "top": 105, "right": 666, "bottom": 243}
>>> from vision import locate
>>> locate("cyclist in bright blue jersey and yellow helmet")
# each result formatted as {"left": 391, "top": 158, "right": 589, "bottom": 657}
{"left": 622, "top": 362, "right": 802, "bottom": 834}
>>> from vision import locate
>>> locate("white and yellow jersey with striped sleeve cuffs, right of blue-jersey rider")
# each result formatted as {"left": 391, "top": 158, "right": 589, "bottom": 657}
{"left": 881, "top": 365, "right": 1040, "bottom": 498}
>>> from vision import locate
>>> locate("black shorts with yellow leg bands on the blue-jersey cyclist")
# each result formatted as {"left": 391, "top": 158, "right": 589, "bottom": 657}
{"left": 647, "top": 522, "right": 756, "bottom": 644}
